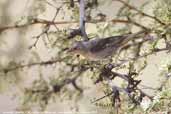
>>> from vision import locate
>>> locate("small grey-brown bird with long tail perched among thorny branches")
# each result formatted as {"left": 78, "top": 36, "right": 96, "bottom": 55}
{"left": 69, "top": 31, "right": 145, "bottom": 60}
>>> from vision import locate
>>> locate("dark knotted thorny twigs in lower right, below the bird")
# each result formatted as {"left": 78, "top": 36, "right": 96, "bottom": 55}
{"left": 92, "top": 60, "right": 153, "bottom": 104}
